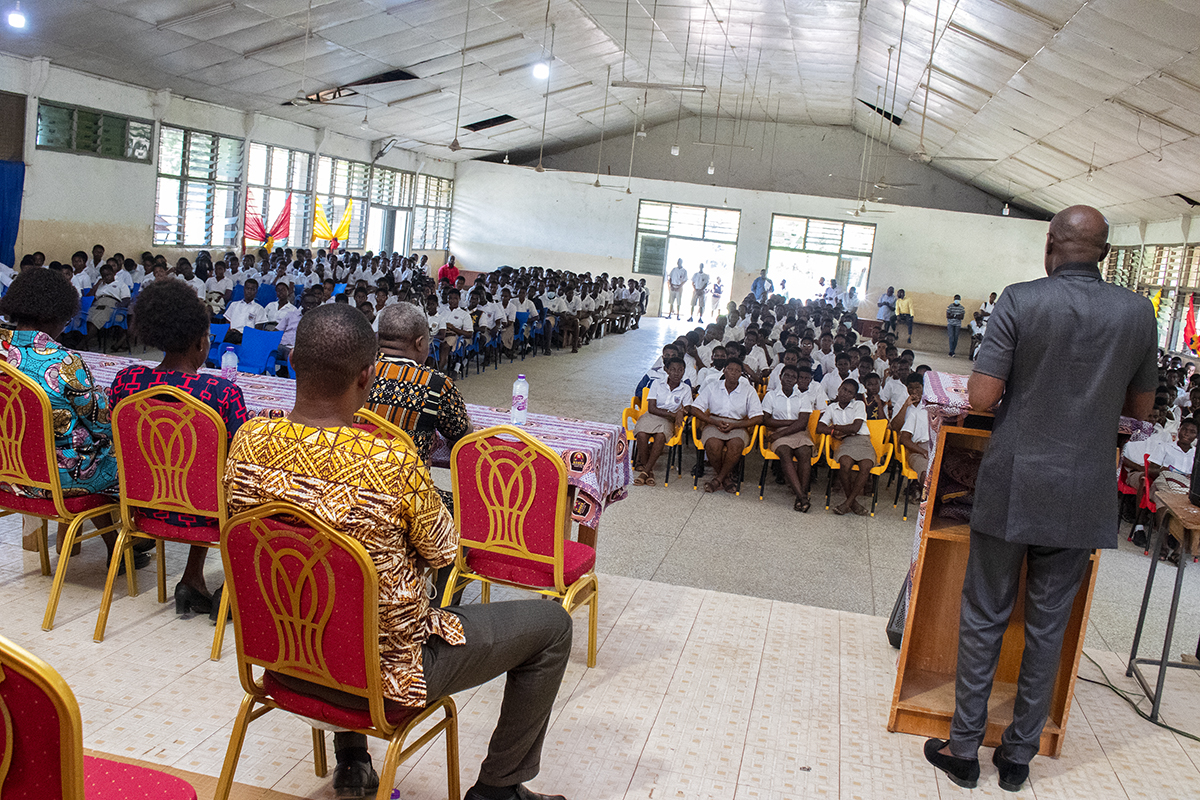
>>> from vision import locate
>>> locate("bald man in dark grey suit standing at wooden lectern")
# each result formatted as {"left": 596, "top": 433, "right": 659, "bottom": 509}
{"left": 925, "top": 205, "right": 1158, "bottom": 792}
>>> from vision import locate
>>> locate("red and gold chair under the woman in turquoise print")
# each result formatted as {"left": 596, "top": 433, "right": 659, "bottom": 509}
{"left": 0, "top": 361, "right": 125, "bottom": 631}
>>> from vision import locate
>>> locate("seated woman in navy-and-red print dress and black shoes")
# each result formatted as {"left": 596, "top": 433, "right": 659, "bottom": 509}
{"left": 108, "top": 279, "right": 250, "bottom": 619}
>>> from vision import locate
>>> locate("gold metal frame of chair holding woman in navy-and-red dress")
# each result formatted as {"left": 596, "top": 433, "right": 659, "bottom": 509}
{"left": 92, "top": 386, "right": 229, "bottom": 661}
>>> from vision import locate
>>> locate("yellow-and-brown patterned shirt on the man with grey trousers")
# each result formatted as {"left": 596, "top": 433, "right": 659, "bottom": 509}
{"left": 226, "top": 417, "right": 467, "bottom": 706}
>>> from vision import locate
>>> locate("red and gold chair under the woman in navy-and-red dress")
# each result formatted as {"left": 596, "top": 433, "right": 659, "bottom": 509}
{"left": 92, "top": 386, "right": 229, "bottom": 661}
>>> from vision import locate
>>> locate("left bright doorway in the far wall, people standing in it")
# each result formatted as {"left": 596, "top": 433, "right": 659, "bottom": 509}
{"left": 634, "top": 200, "right": 742, "bottom": 320}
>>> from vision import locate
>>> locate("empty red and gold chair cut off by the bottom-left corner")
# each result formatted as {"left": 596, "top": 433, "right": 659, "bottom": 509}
{"left": 0, "top": 637, "right": 196, "bottom": 800}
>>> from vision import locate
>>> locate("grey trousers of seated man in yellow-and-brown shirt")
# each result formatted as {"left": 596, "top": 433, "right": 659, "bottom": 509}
{"left": 326, "top": 600, "right": 571, "bottom": 786}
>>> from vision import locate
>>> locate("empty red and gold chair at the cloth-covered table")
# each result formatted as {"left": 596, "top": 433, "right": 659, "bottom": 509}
{"left": 442, "top": 425, "right": 600, "bottom": 667}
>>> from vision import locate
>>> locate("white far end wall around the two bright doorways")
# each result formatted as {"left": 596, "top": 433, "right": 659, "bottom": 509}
{"left": 450, "top": 162, "right": 1046, "bottom": 324}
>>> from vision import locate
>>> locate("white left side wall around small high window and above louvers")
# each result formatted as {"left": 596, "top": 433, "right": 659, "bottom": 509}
{"left": 0, "top": 53, "right": 454, "bottom": 261}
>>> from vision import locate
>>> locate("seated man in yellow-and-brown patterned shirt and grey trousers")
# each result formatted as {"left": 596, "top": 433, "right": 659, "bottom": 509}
{"left": 226, "top": 303, "right": 571, "bottom": 800}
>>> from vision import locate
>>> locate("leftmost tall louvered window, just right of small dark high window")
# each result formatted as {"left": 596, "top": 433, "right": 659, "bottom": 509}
{"left": 154, "top": 125, "right": 245, "bottom": 247}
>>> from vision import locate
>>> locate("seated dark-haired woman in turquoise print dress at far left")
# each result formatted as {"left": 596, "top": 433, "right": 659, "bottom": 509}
{"left": 0, "top": 270, "right": 150, "bottom": 567}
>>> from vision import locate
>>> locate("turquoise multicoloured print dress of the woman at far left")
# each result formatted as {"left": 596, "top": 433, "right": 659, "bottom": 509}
{"left": 0, "top": 330, "right": 116, "bottom": 498}
